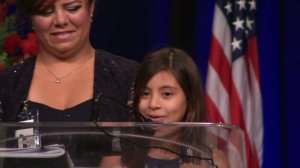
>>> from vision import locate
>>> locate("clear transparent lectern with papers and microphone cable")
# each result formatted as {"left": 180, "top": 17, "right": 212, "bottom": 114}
{"left": 0, "top": 122, "right": 247, "bottom": 168}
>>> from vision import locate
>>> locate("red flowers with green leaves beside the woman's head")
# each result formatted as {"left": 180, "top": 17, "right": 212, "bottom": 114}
{"left": 0, "top": 0, "right": 39, "bottom": 70}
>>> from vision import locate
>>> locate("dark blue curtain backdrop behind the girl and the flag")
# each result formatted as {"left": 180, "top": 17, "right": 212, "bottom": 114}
{"left": 91, "top": 0, "right": 300, "bottom": 168}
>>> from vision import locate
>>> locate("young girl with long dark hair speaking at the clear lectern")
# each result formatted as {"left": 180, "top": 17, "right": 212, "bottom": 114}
{"left": 124, "top": 48, "right": 227, "bottom": 168}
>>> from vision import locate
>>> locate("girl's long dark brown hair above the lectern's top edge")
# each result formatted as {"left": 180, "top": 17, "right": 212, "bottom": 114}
{"left": 132, "top": 47, "right": 206, "bottom": 122}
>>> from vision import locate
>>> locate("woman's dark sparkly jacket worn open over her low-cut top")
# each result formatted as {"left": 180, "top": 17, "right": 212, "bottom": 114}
{"left": 0, "top": 50, "right": 138, "bottom": 122}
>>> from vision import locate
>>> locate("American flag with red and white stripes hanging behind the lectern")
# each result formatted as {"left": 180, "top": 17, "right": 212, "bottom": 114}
{"left": 206, "top": 0, "right": 263, "bottom": 168}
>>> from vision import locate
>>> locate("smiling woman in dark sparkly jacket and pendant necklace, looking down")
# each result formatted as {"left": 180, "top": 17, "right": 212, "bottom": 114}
{"left": 0, "top": 0, "right": 137, "bottom": 122}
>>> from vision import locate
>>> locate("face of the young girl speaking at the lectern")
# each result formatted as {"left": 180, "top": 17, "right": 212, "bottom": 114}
{"left": 139, "top": 71, "right": 187, "bottom": 136}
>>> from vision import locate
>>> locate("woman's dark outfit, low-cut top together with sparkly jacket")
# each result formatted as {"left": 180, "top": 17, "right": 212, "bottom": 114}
{"left": 0, "top": 50, "right": 138, "bottom": 122}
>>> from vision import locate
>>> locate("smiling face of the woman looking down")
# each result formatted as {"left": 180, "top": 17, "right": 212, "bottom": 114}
{"left": 32, "top": 0, "right": 93, "bottom": 53}
